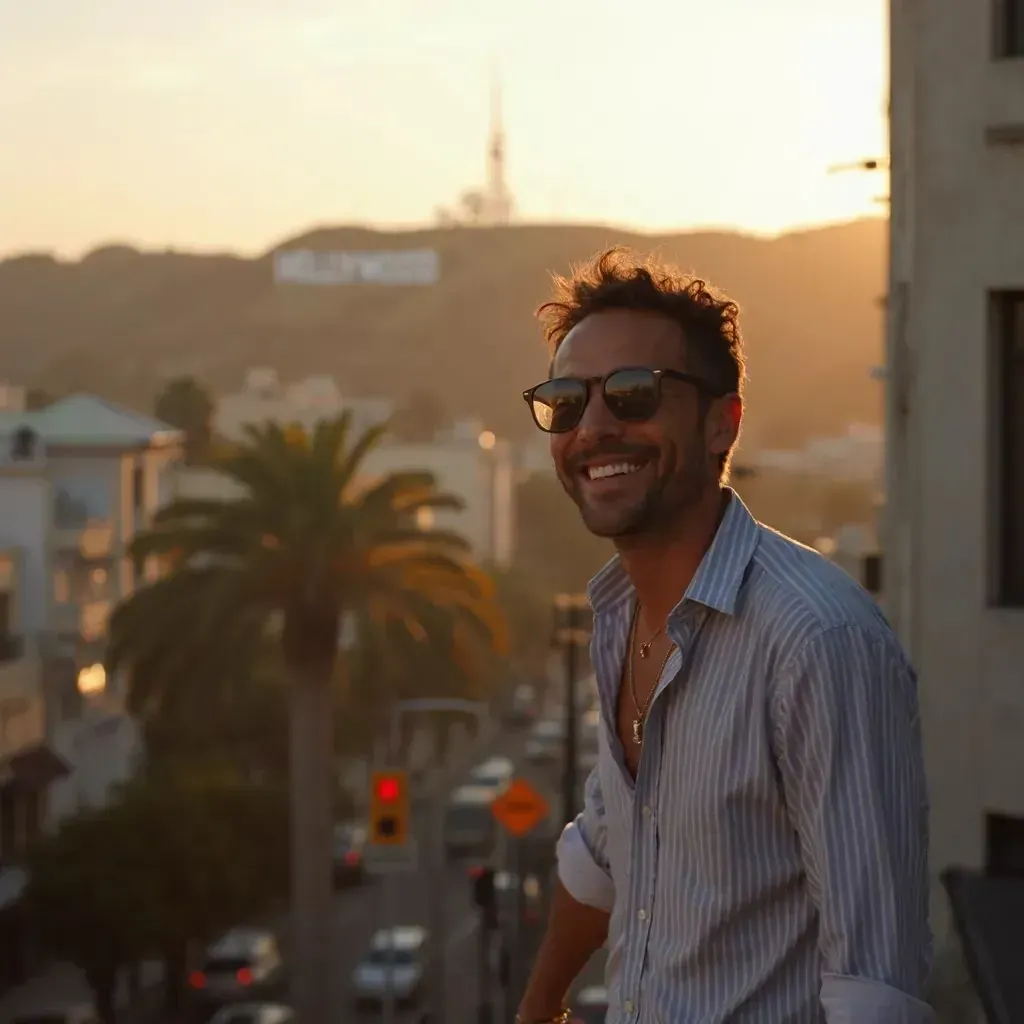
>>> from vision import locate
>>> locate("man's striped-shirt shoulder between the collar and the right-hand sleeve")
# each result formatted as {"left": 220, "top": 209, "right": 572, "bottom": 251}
{"left": 743, "top": 525, "right": 893, "bottom": 646}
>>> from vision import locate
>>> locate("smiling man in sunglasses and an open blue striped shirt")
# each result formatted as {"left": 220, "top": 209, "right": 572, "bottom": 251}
{"left": 518, "top": 251, "right": 934, "bottom": 1024}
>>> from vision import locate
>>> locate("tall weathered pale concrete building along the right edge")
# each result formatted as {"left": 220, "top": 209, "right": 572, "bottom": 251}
{"left": 883, "top": 0, "right": 1024, "bottom": 917}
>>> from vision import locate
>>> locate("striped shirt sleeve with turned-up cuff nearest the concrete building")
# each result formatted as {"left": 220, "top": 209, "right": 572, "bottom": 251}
{"left": 773, "top": 626, "right": 935, "bottom": 1024}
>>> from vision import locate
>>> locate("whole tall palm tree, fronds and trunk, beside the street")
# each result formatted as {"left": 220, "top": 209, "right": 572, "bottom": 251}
{"left": 109, "top": 415, "right": 503, "bottom": 1024}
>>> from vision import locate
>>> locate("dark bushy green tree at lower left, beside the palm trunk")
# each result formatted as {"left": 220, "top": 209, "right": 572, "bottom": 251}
{"left": 28, "top": 777, "right": 288, "bottom": 1024}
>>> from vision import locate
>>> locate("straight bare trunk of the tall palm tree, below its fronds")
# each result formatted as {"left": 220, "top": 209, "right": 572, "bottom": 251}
{"left": 289, "top": 666, "right": 335, "bottom": 1024}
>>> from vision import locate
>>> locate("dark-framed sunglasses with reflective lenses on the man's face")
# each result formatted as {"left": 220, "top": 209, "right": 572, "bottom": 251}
{"left": 522, "top": 367, "right": 718, "bottom": 434}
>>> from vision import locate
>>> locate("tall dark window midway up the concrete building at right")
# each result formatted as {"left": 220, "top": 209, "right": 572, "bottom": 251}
{"left": 991, "top": 292, "right": 1024, "bottom": 607}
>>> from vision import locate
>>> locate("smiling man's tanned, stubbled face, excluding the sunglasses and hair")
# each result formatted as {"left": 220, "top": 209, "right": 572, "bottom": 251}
{"left": 551, "top": 310, "right": 739, "bottom": 540}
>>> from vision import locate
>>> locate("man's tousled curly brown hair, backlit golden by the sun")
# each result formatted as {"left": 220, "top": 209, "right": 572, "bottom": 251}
{"left": 537, "top": 247, "right": 746, "bottom": 394}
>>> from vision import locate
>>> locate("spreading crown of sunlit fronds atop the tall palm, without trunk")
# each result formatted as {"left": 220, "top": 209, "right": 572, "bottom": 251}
{"left": 108, "top": 416, "right": 507, "bottom": 741}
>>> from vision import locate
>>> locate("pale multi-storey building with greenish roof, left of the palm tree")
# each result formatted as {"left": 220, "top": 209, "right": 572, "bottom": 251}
{"left": 0, "top": 395, "right": 182, "bottom": 824}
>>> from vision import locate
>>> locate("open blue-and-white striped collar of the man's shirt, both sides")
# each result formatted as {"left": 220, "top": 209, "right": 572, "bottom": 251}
{"left": 587, "top": 487, "right": 761, "bottom": 618}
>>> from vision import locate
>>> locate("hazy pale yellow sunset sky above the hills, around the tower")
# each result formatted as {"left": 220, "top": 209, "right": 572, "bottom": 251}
{"left": 0, "top": 0, "right": 886, "bottom": 254}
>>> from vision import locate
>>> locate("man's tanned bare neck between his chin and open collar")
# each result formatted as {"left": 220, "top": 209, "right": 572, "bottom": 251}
{"left": 620, "top": 486, "right": 727, "bottom": 634}
